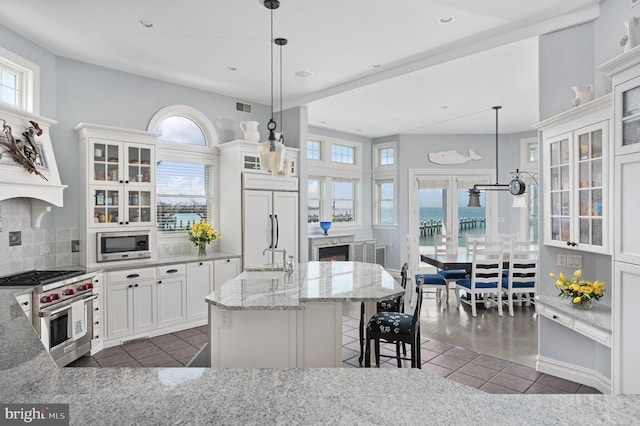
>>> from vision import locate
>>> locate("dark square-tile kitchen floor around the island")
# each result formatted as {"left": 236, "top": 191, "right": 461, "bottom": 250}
{"left": 69, "top": 316, "right": 600, "bottom": 394}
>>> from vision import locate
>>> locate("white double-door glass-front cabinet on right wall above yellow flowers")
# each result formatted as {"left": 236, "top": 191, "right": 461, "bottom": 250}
{"left": 535, "top": 95, "right": 612, "bottom": 254}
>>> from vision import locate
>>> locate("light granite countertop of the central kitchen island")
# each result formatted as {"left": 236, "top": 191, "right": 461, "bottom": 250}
{"left": 207, "top": 262, "right": 404, "bottom": 310}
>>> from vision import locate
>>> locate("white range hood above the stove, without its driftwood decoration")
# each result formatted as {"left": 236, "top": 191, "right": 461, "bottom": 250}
{"left": 0, "top": 104, "right": 67, "bottom": 228}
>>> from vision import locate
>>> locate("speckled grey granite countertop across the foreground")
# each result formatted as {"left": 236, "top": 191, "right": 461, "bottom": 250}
{"left": 0, "top": 289, "right": 640, "bottom": 426}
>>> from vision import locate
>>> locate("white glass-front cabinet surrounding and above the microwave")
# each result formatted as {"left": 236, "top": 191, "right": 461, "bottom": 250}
{"left": 74, "top": 123, "right": 157, "bottom": 267}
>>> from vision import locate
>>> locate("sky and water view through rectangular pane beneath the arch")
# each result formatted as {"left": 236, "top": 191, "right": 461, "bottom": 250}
{"left": 156, "top": 161, "right": 213, "bottom": 231}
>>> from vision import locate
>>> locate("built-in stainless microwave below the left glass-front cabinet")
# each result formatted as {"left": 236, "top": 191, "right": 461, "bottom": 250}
{"left": 96, "top": 231, "right": 151, "bottom": 262}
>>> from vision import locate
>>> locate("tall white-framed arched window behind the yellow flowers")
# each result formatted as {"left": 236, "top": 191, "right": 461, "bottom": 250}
{"left": 148, "top": 105, "right": 219, "bottom": 238}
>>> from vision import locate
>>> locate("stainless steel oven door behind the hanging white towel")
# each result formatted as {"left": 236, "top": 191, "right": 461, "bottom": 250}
{"left": 40, "top": 295, "right": 97, "bottom": 367}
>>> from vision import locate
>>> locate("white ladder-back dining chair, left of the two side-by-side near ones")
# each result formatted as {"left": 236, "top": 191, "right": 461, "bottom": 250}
{"left": 456, "top": 241, "right": 503, "bottom": 317}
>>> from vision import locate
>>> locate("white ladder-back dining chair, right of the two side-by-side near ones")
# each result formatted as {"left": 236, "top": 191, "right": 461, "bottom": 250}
{"left": 501, "top": 241, "right": 539, "bottom": 316}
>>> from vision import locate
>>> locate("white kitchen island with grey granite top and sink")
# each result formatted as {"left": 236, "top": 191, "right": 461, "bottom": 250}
{"left": 207, "top": 262, "right": 405, "bottom": 368}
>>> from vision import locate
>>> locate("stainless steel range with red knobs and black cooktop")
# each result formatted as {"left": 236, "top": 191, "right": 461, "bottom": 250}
{"left": 0, "top": 270, "right": 98, "bottom": 367}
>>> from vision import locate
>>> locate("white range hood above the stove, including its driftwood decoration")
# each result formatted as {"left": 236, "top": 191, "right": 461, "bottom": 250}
{"left": 0, "top": 105, "right": 67, "bottom": 228}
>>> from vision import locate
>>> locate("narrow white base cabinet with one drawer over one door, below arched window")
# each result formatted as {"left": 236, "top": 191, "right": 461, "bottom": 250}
{"left": 156, "top": 264, "right": 187, "bottom": 327}
